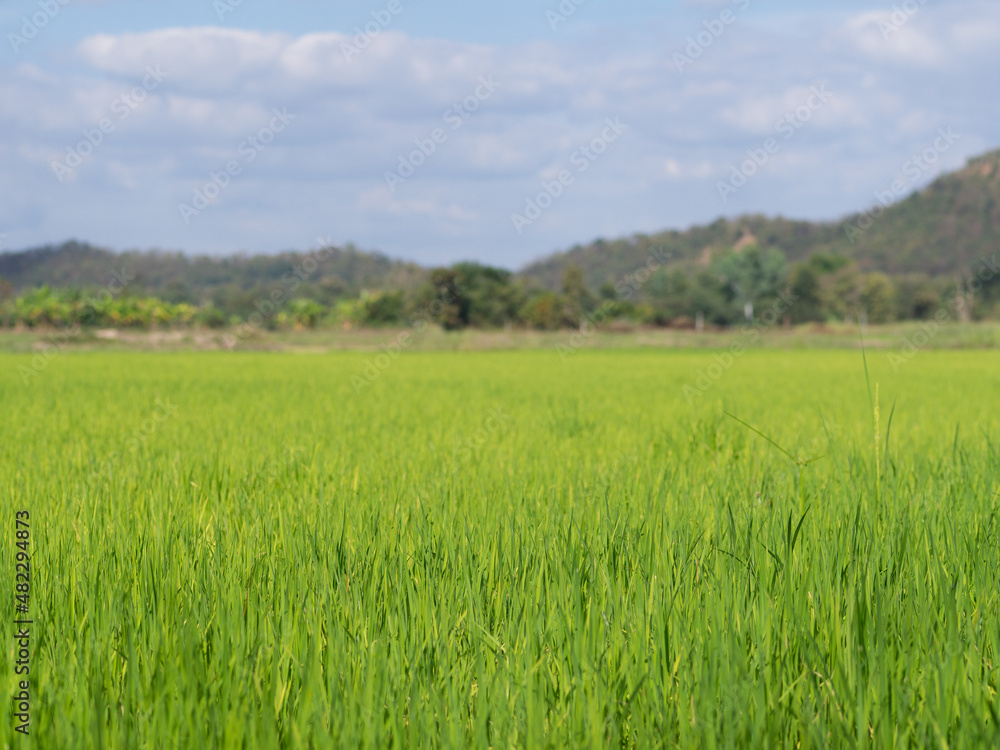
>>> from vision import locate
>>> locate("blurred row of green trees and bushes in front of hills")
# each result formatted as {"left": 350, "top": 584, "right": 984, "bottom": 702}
{"left": 0, "top": 244, "right": 1000, "bottom": 330}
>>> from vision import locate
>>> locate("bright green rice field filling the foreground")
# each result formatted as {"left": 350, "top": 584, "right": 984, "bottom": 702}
{"left": 0, "top": 349, "right": 1000, "bottom": 749}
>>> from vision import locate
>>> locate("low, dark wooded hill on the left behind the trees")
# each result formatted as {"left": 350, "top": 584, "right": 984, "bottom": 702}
{"left": 0, "top": 241, "right": 425, "bottom": 304}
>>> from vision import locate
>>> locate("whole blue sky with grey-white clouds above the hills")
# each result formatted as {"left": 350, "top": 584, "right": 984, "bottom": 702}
{"left": 0, "top": 0, "right": 1000, "bottom": 268}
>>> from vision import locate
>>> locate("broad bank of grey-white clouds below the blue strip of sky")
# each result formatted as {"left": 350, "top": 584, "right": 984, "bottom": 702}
{"left": 0, "top": 0, "right": 1000, "bottom": 265}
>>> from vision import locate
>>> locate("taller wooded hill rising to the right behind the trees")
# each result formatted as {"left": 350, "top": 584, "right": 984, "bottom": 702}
{"left": 521, "top": 150, "right": 1000, "bottom": 289}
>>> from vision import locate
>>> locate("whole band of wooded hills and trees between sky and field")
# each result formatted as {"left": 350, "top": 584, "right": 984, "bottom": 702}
{"left": 0, "top": 152, "right": 1000, "bottom": 329}
